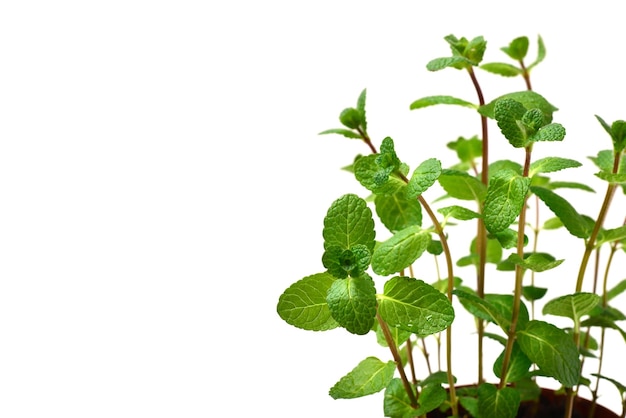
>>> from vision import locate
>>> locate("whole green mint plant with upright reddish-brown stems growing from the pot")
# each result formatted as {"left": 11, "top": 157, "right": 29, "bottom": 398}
{"left": 277, "top": 35, "right": 626, "bottom": 418}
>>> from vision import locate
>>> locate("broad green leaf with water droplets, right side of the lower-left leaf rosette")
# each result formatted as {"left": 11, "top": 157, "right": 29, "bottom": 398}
{"left": 378, "top": 277, "right": 454, "bottom": 336}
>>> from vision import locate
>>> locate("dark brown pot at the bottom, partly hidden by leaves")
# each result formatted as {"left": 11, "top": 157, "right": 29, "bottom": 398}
{"left": 427, "top": 388, "right": 620, "bottom": 418}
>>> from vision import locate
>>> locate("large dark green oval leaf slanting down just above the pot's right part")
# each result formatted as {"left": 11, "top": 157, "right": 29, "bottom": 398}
{"left": 516, "top": 320, "right": 580, "bottom": 387}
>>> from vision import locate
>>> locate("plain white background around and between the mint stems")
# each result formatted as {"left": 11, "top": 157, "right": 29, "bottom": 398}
{"left": 0, "top": 0, "right": 626, "bottom": 418}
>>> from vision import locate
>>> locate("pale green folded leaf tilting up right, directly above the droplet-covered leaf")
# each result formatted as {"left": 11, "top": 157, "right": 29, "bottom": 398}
{"left": 372, "top": 226, "right": 431, "bottom": 276}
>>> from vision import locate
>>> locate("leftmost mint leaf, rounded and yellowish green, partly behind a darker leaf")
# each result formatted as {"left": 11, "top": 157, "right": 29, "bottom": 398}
{"left": 276, "top": 273, "right": 339, "bottom": 331}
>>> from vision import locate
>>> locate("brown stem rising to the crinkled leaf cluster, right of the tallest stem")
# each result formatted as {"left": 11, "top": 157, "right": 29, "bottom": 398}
{"left": 499, "top": 144, "right": 532, "bottom": 389}
